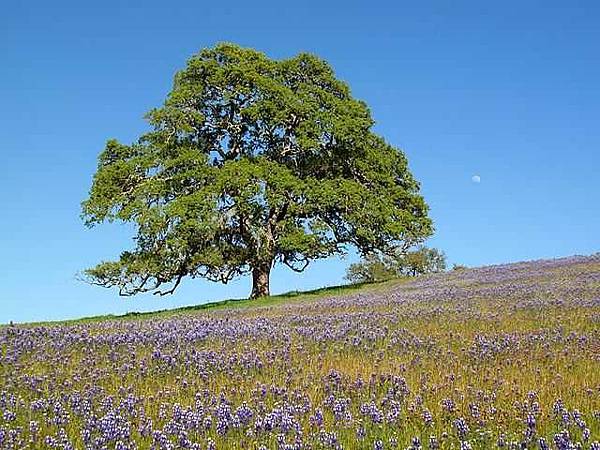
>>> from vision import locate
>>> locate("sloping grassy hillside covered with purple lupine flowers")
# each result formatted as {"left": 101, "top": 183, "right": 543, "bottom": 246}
{"left": 0, "top": 255, "right": 600, "bottom": 450}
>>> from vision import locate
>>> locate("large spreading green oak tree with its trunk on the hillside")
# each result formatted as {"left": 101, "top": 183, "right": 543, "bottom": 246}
{"left": 82, "top": 44, "right": 432, "bottom": 297}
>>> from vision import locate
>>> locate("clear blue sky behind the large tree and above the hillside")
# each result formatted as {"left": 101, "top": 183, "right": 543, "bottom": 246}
{"left": 0, "top": 0, "right": 600, "bottom": 322}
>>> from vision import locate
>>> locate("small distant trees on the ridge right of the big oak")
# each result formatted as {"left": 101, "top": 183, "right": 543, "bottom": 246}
{"left": 346, "top": 246, "right": 446, "bottom": 283}
